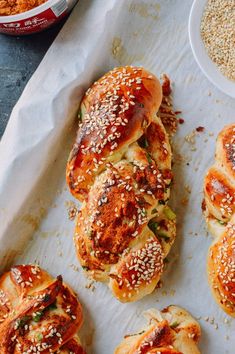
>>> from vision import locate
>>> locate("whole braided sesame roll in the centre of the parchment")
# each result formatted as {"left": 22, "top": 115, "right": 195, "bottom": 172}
{"left": 67, "top": 66, "right": 176, "bottom": 302}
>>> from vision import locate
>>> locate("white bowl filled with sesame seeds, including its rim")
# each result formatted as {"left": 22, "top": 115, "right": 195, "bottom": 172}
{"left": 189, "top": 0, "right": 235, "bottom": 98}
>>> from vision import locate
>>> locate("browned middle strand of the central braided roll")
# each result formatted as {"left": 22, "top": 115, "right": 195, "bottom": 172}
{"left": 76, "top": 158, "right": 171, "bottom": 269}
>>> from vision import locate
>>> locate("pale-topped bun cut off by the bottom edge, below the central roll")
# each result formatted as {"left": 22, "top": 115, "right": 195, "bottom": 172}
{"left": 114, "top": 306, "right": 201, "bottom": 354}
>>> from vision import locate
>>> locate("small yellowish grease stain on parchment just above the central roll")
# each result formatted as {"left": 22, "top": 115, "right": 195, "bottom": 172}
{"left": 112, "top": 37, "right": 144, "bottom": 65}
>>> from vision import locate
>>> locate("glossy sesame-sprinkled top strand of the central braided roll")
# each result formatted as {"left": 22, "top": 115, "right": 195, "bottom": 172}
{"left": 67, "top": 66, "right": 162, "bottom": 200}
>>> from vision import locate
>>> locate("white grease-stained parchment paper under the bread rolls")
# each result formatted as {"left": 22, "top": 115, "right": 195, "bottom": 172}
{"left": 0, "top": 0, "right": 235, "bottom": 354}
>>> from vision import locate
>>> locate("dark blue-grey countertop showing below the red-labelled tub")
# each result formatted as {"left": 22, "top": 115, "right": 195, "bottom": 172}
{"left": 0, "top": 20, "right": 65, "bottom": 138}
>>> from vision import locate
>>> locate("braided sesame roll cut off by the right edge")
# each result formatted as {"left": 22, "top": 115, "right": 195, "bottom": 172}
{"left": 203, "top": 124, "right": 235, "bottom": 317}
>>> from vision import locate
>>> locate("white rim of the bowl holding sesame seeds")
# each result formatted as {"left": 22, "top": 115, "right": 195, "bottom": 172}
{"left": 188, "top": 0, "right": 235, "bottom": 98}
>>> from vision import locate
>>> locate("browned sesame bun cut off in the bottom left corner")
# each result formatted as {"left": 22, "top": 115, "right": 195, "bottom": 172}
{"left": 0, "top": 265, "right": 85, "bottom": 354}
